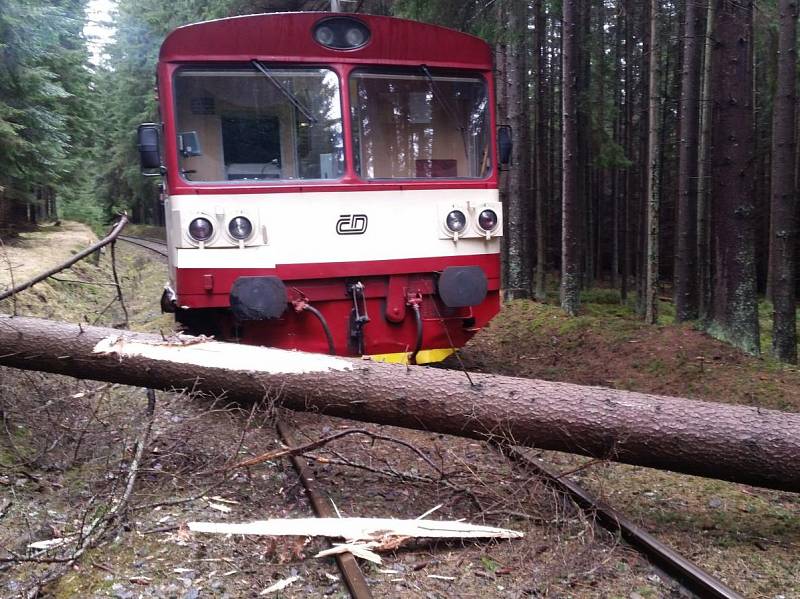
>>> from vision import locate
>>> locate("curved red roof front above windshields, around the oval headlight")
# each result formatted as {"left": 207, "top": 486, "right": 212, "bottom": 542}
{"left": 160, "top": 12, "right": 492, "bottom": 70}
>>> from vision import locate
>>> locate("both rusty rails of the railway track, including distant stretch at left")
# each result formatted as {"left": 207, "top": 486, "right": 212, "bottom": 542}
{"left": 119, "top": 236, "right": 743, "bottom": 599}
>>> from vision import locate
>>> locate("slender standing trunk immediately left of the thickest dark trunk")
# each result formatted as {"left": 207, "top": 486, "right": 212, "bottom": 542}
{"left": 697, "top": 0, "right": 716, "bottom": 321}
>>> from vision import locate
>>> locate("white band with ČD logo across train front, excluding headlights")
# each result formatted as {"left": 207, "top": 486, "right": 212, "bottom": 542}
{"left": 166, "top": 189, "right": 503, "bottom": 269}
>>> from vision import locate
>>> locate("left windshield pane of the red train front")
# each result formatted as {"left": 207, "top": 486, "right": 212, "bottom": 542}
{"left": 175, "top": 62, "right": 344, "bottom": 182}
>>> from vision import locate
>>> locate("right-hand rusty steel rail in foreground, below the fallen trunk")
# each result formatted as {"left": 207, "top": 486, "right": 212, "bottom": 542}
{"left": 501, "top": 446, "right": 744, "bottom": 599}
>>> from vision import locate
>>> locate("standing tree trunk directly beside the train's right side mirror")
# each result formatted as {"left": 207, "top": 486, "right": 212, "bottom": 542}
{"left": 506, "top": 0, "right": 531, "bottom": 299}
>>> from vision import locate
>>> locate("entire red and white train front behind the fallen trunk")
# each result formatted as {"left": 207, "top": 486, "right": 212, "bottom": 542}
{"left": 144, "top": 13, "right": 503, "bottom": 363}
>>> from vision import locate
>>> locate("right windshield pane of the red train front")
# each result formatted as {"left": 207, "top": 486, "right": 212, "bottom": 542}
{"left": 350, "top": 67, "right": 492, "bottom": 179}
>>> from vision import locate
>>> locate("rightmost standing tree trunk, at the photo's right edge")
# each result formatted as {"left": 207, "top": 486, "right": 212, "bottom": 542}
{"left": 770, "top": 0, "right": 797, "bottom": 364}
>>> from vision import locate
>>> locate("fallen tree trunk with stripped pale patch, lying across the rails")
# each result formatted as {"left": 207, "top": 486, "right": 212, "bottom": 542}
{"left": 0, "top": 317, "right": 800, "bottom": 491}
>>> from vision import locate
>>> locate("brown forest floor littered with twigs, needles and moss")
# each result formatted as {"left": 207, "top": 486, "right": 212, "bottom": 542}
{"left": 0, "top": 223, "right": 800, "bottom": 599}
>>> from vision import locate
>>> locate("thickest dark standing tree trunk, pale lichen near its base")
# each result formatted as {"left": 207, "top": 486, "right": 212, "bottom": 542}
{"left": 710, "top": 0, "right": 761, "bottom": 354}
